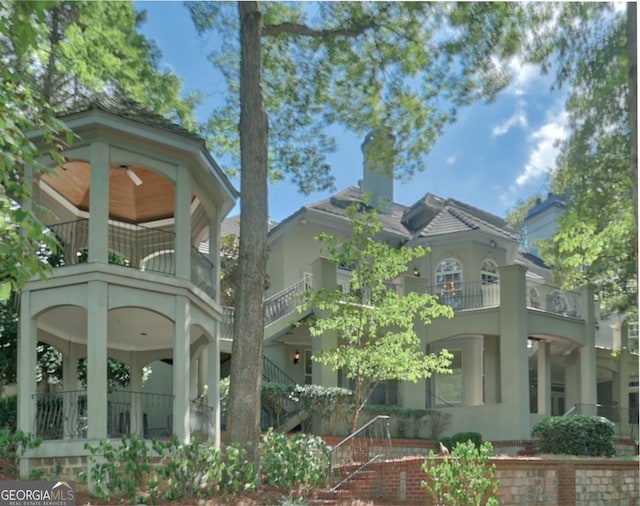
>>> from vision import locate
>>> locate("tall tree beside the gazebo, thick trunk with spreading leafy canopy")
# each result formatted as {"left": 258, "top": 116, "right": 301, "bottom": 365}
{"left": 187, "top": 2, "right": 526, "bottom": 461}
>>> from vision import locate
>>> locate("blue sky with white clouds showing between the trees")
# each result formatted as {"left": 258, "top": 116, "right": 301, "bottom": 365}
{"left": 135, "top": 1, "right": 567, "bottom": 221}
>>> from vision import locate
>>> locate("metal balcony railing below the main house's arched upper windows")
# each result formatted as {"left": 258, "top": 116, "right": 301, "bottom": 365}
{"left": 427, "top": 281, "right": 500, "bottom": 311}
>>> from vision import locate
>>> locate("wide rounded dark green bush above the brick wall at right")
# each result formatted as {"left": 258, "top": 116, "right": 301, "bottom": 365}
{"left": 532, "top": 415, "right": 616, "bottom": 457}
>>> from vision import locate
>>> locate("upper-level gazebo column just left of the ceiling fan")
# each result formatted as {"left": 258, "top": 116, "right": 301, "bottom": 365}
{"left": 89, "top": 142, "right": 110, "bottom": 264}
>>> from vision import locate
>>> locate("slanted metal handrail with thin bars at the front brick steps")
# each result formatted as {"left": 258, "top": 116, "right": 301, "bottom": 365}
{"left": 329, "top": 415, "right": 391, "bottom": 492}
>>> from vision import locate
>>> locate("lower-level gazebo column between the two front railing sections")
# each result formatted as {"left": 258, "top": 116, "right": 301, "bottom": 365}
{"left": 87, "top": 281, "right": 108, "bottom": 439}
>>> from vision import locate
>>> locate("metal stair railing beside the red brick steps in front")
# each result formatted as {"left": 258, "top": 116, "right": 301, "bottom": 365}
{"left": 330, "top": 415, "right": 391, "bottom": 492}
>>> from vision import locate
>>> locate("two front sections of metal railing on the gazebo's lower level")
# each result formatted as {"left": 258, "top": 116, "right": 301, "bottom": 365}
{"left": 33, "top": 390, "right": 173, "bottom": 439}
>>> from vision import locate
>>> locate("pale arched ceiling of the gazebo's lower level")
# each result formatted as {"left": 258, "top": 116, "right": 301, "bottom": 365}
{"left": 37, "top": 306, "right": 180, "bottom": 351}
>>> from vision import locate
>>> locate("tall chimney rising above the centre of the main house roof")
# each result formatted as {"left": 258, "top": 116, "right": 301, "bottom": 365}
{"left": 361, "top": 130, "right": 395, "bottom": 214}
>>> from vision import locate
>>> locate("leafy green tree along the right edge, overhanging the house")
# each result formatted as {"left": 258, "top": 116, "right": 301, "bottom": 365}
{"left": 520, "top": 3, "right": 637, "bottom": 312}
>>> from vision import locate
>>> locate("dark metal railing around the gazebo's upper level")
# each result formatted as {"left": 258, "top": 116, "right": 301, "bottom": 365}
{"left": 49, "top": 219, "right": 217, "bottom": 298}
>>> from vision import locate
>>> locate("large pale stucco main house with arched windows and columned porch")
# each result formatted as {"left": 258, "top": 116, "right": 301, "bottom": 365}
{"left": 229, "top": 135, "right": 637, "bottom": 440}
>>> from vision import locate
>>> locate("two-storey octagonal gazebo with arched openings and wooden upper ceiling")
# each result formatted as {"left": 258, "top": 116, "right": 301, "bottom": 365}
{"left": 18, "top": 99, "right": 238, "bottom": 477}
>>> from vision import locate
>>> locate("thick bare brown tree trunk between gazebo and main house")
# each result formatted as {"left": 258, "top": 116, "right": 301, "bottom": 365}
{"left": 227, "top": 2, "right": 268, "bottom": 463}
